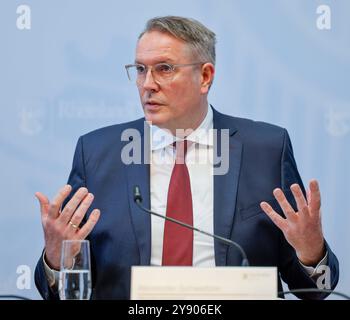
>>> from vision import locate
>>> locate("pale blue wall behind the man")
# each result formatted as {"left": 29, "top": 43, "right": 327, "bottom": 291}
{"left": 0, "top": 0, "right": 350, "bottom": 298}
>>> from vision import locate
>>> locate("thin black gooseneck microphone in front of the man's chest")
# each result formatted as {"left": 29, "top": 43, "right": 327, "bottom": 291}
{"left": 134, "top": 186, "right": 249, "bottom": 267}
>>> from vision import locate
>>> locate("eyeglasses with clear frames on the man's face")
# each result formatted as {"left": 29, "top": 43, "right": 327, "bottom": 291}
{"left": 125, "top": 62, "right": 205, "bottom": 85}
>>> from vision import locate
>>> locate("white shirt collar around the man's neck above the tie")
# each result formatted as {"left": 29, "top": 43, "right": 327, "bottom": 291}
{"left": 150, "top": 107, "right": 213, "bottom": 151}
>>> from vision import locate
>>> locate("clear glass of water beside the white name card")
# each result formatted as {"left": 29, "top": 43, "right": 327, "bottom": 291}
{"left": 58, "top": 240, "right": 91, "bottom": 300}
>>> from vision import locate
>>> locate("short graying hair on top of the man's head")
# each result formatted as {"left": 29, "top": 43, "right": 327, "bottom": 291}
{"left": 139, "top": 16, "right": 216, "bottom": 65}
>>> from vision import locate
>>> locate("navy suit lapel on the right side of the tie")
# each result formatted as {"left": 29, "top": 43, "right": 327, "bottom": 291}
{"left": 213, "top": 109, "right": 242, "bottom": 266}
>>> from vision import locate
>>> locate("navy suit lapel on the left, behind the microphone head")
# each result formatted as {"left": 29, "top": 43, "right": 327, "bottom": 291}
{"left": 126, "top": 121, "right": 151, "bottom": 265}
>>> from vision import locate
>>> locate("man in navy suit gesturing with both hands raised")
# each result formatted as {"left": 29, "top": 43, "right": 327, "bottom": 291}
{"left": 35, "top": 17, "right": 339, "bottom": 299}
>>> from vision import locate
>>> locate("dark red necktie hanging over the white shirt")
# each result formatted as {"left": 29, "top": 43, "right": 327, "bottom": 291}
{"left": 162, "top": 140, "right": 193, "bottom": 266}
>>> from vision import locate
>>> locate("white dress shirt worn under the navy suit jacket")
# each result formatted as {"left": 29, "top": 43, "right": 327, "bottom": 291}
{"left": 150, "top": 108, "right": 215, "bottom": 267}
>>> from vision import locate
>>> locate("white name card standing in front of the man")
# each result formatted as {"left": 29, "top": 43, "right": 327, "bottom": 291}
{"left": 130, "top": 266, "right": 277, "bottom": 300}
